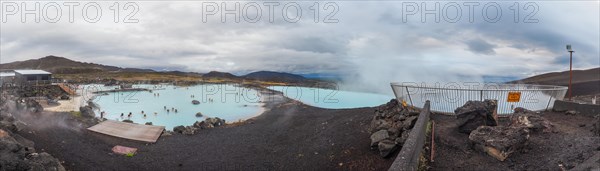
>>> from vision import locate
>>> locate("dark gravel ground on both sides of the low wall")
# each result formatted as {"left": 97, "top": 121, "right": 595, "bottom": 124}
{"left": 14, "top": 92, "right": 600, "bottom": 171}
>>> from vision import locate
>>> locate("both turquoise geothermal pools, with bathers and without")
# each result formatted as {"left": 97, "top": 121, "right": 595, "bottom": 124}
{"left": 83, "top": 84, "right": 393, "bottom": 129}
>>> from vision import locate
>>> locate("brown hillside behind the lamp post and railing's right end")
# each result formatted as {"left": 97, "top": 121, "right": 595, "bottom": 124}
{"left": 512, "top": 68, "right": 600, "bottom": 96}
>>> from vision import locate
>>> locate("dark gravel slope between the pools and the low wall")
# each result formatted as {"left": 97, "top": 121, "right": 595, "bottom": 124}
{"left": 14, "top": 97, "right": 395, "bottom": 170}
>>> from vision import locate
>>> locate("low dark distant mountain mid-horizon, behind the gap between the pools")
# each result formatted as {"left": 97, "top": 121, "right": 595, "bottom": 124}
{"left": 242, "top": 71, "right": 308, "bottom": 83}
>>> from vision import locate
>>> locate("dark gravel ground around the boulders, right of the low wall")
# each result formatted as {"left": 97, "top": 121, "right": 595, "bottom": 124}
{"left": 430, "top": 112, "right": 600, "bottom": 171}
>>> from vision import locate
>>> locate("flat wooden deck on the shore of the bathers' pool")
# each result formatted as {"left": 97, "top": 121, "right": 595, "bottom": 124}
{"left": 88, "top": 120, "right": 165, "bottom": 143}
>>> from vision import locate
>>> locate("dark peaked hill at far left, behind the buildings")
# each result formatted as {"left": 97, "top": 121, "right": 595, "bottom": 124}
{"left": 0, "top": 56, "right": 154, "bottom": 74}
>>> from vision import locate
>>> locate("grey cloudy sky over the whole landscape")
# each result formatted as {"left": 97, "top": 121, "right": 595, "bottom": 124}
{"left": 0, "top": 0, "right": 600, "bottom": 91}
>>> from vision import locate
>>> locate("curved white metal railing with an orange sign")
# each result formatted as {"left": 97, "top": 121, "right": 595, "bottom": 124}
{"left": 391, "top": 83, "right": 568, "bottom": 115}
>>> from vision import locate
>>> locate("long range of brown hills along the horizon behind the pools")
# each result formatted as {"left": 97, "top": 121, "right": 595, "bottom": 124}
{"left": 0, "top": 56, "right": 333, "bottom": 87}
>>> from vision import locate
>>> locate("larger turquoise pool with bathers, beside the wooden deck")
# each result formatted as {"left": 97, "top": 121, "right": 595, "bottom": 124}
{"left": 86, "top": 84, "right": 262, "bottom": 129}
